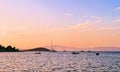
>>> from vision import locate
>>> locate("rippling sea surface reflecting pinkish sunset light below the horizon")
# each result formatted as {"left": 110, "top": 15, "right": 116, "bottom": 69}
{"left": 0, "top": 52, "right": 120, "bottom": 72}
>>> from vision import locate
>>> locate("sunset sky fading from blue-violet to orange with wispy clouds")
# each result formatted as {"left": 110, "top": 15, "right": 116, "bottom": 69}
{"left": 0, "top": 0, "right": 120, "bottom": 50}
